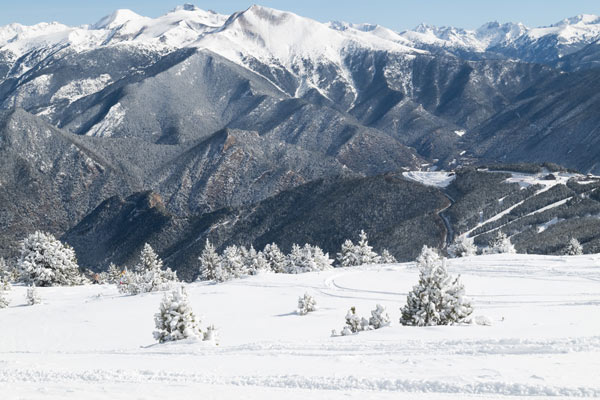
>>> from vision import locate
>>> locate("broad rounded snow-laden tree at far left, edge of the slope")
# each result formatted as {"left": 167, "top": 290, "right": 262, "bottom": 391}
{"left": 17, "top": 232, "right": 85, "bottom": 286}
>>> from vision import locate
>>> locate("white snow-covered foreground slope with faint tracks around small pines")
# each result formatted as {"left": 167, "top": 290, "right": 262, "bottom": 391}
{"left": 0, "top": 255, "right": 600, "bottom": 400}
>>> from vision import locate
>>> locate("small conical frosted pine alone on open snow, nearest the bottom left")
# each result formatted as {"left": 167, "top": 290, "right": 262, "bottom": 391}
{"left": 153, "top": 287, "right": 203, "bottom": 343}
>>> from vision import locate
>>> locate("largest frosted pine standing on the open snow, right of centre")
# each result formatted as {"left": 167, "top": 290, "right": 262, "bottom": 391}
{"left": 400, "top": 259, "right": 473, "bottom": 326}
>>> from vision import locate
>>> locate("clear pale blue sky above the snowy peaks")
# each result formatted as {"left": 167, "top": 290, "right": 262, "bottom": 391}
{"left": 0, "top": 0, "right": 600, "bottom": 31}
